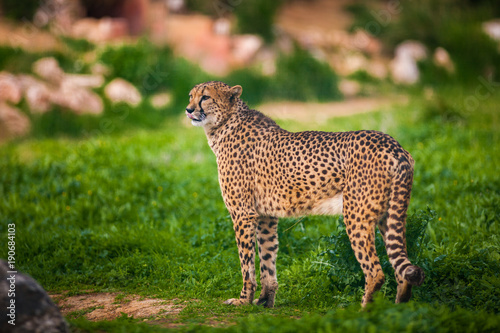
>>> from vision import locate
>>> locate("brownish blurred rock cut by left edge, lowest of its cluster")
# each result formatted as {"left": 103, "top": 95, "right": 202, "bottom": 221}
{"left": 0, "top": 102, "right": 31, "bottom": 141}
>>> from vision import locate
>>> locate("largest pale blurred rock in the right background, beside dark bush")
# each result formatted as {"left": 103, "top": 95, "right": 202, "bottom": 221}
{"left": 389, "top": 41, "right": 427, "bottom": 84}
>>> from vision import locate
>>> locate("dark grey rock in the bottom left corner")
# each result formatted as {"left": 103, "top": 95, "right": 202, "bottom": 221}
{"left": 0, "top": 260, "right": 69, "bottom": 333}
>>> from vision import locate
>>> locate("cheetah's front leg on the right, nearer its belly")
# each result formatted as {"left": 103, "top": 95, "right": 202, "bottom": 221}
{"left": 256, "top": 216, "right": 278, "bottom": 308}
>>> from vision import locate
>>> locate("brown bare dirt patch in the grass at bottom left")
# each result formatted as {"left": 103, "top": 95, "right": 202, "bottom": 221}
{"left": 51, "top": 293, "right": 185, "bottom": 321}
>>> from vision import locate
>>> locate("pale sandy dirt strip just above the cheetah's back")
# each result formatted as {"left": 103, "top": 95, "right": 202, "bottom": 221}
{"left": 257, "top": 96, "right": 408, "bottom": 123}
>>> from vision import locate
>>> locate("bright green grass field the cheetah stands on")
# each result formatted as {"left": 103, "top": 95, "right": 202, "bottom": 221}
{"left": 0, "top": 83, "right": 500, "bottom": 332}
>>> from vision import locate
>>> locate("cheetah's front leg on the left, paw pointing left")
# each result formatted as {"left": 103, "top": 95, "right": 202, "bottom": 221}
{"left": 224, "top": 213, "right": 257, "bottom": 305}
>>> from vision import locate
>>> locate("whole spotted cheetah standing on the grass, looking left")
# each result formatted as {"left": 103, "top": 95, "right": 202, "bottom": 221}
{"left": 185, "top": 81, "right": 425, "bottom": 307}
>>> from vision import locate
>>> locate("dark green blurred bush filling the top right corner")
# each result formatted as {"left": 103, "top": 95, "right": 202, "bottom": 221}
{"left": 347, "top": 0, "right": 500, "bottom": 84}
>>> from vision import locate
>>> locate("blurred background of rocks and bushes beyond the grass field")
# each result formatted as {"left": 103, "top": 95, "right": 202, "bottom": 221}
{"left": 0, "top": 0, "right": 500, "bottom": 141}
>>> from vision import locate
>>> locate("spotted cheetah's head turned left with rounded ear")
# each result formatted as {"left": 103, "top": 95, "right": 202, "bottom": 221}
{"left": 186, "top": 81, "right": 242, "bottom": 129}
